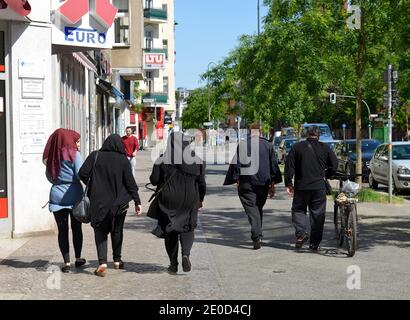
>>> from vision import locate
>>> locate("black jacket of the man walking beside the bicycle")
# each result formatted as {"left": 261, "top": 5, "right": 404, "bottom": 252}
{"left": 285, "top": 138, "right": 338, "bottom": 190}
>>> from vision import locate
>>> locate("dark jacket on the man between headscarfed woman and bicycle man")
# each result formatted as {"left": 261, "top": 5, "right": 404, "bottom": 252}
{"left": 224, "top": 135, "right": 282, "bottom": 186}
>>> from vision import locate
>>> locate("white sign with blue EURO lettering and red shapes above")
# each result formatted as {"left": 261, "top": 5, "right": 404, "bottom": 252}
{"left": 52, "top": 0, "right": 118, "bottom": 49}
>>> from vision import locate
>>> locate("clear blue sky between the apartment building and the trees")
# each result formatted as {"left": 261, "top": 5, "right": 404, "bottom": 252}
{"left": 175, "top": 0, "right": 267, "bottom": 89}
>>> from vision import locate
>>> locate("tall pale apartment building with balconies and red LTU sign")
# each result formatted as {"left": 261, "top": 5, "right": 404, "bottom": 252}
{"left": 139, "top": 0, "right": 176, "bottom": 147}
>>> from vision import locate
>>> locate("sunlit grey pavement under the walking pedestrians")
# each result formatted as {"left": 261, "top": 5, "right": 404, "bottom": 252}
{"left": 0, "top": 151, "right": 410, "bottom": 300}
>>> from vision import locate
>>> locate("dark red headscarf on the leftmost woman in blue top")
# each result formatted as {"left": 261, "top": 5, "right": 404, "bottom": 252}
{"left": 43, "top": 129, "right": 81, "bottom": 181}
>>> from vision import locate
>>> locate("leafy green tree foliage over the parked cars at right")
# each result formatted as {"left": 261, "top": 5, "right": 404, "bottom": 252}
{"left": 191, "top": 0, "right": 410, "bottom": 132}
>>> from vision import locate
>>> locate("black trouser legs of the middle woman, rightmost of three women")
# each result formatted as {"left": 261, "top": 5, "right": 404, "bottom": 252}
{"left": 165, "top": 231, "right": 195, "bottom": 266}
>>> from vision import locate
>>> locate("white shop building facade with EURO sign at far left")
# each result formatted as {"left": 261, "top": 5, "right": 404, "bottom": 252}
{"left": 0, "top": 0, "right": 121, "bottom": 237}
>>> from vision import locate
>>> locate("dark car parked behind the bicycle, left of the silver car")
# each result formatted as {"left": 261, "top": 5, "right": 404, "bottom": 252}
{"left": 334, "top": 139, "right": 380, "bottom": 179}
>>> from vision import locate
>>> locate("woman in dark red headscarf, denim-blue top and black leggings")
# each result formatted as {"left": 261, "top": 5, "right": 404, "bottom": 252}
{"left": 43, "top": 129, "right": 86, "bottom": 273}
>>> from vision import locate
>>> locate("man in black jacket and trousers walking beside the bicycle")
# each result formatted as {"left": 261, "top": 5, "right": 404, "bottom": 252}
{"left": 285, "top": 126, "right": 338, "bottom": 251}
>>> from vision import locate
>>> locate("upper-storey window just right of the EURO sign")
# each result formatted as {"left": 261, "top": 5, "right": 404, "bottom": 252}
{"left": 114, "top": 0, "right": 130, "bottom": 46}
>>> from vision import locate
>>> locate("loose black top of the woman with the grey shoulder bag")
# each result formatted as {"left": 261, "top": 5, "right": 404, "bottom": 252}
{"left": 79, "top": 136, "right": 141, "bottom": 228}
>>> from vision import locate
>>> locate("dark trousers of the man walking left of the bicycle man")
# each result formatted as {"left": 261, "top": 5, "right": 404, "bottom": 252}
{"left": 238, "top": 182, "right": 269, "bottom": 241}
